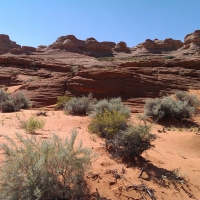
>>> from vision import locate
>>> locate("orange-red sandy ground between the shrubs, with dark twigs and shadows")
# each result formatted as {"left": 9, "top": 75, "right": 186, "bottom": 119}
{"left": 0, "top": 110, "right": 200, "bottom": 200}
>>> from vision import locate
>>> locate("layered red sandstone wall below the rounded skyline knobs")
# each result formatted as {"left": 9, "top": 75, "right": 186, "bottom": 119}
{"left": 0, "top": 53, "right": 200, "bottom": 111}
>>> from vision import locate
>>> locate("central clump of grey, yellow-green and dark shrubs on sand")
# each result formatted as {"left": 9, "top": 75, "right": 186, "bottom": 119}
{"left": 88, "top": 98, "right": 155, "bottom": 157}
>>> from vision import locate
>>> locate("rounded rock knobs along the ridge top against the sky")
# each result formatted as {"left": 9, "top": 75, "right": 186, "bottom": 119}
{"left": 0, "top": 30, "right": 200, "bottom": 57}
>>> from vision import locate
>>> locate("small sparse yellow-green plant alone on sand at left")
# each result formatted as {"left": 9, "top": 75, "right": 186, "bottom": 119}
{"left": 20, "top": 116, "right": 45, "bottom": 134}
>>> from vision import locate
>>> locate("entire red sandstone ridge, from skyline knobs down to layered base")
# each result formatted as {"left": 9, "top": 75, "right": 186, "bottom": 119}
{"left": 0, "top": 31, "right": 200, "bottom": 111}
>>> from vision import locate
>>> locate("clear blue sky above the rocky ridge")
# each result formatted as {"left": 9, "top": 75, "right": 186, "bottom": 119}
{"left": 0, "top": 0, "right": 200, "bottom": 47}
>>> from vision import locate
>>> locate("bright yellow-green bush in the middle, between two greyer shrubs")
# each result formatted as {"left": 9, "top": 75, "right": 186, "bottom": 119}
{"left": 88, "top": 109, "right": 128, "bottom": 138}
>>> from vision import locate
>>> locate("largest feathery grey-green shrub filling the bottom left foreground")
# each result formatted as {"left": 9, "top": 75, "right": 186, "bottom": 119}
{"left": 0, "top": 131, "right": 91, "bottom": 200}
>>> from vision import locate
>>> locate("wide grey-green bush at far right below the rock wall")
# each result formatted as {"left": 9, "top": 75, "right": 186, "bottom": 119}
{"left": 144, "top": 92, "right": 199, "bottom": 120}
